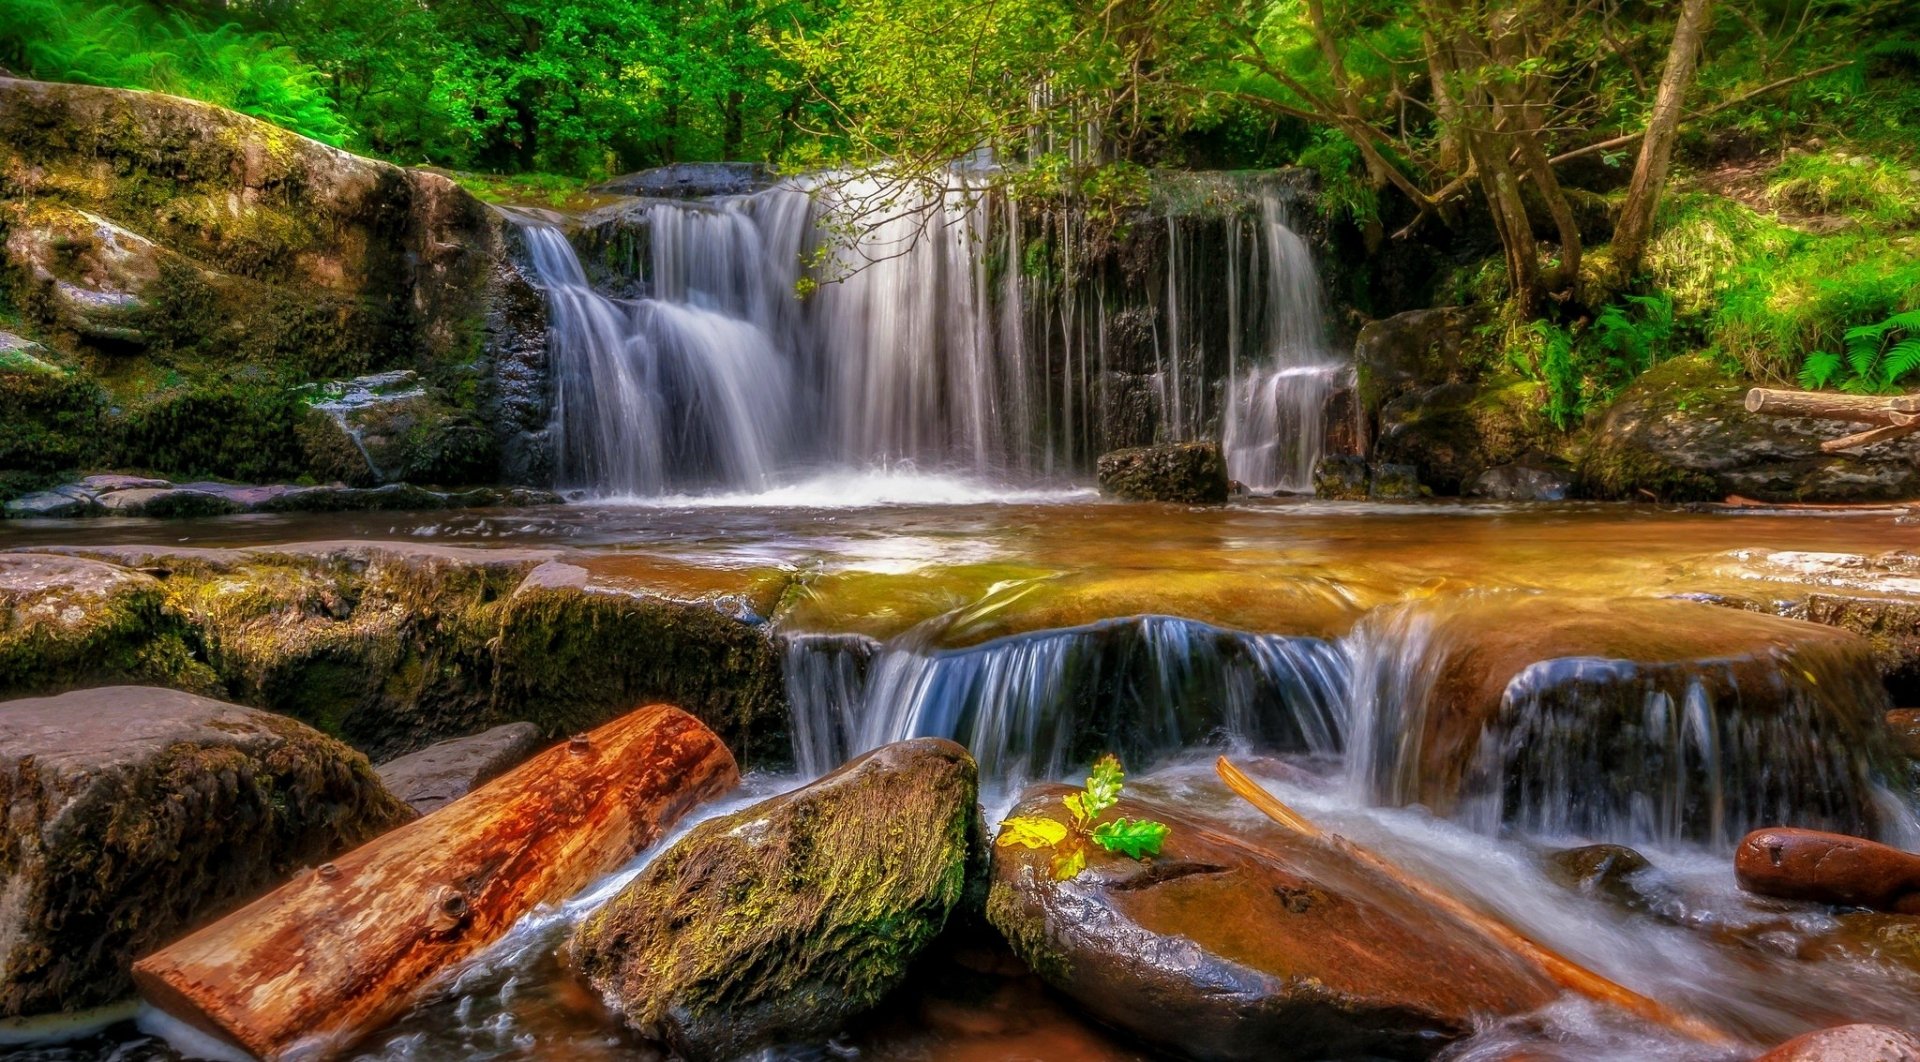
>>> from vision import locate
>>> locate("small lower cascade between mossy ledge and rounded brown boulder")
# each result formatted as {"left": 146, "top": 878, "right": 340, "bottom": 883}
{"left": 787, "top": 616, "right": 1346, "bottom": 782}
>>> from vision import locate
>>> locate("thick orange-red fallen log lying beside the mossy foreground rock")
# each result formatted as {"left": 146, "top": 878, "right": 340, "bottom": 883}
{"left": 132, "top": 705, "right": 739, "bottom": 1060}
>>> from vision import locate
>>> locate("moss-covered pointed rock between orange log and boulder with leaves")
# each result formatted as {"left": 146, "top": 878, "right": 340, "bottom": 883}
{"left": 572, "top": 737, "right": 979, "bottom": 1060}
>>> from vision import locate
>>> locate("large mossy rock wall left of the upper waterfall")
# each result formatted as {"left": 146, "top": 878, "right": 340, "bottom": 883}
{"left": 0, "top": 77, "right": 545, "bottom": 501}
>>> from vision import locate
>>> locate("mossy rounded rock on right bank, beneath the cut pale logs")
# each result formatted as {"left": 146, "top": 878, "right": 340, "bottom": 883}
{"left": 1580, "top": 355, "right": 1920, "bottom": 501}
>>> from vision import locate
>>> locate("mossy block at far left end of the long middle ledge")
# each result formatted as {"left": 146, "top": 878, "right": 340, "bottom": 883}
{"left": 0, "top": 553, "right": 217, "bottom": 697}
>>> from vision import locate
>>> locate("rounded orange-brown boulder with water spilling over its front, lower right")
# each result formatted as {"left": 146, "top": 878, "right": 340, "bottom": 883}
{"left": 1350, "top": 593, "right": 1891, "bottom": 845}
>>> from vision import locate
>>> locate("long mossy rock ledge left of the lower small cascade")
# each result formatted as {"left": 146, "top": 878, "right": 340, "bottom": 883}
{"left": 0, "top": 542, "right": 791, "bottom": 760}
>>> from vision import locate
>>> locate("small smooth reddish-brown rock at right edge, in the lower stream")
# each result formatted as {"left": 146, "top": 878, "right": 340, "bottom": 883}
{"left": 1734, "top": 826, "right": 1920, "bottom": 914}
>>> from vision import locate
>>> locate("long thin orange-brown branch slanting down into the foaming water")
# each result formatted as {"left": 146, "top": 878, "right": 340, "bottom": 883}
{"left": 1213, "top": 757, "right": 1738, "bottom": 1047}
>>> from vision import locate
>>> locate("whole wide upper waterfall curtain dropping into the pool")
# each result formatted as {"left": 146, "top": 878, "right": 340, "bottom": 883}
{"left": 511, "top": 173, "right": 1346, "bottom": 497}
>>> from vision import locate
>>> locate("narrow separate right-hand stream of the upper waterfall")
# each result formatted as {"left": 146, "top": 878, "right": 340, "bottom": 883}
{"left": 1221, "top": 190, "right": 1354, "bottom": 494}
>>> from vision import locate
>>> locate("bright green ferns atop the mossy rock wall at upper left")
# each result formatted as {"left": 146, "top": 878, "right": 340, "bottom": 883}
{"left": 0, "top": 0, "right": 348, "bottom": 144}
